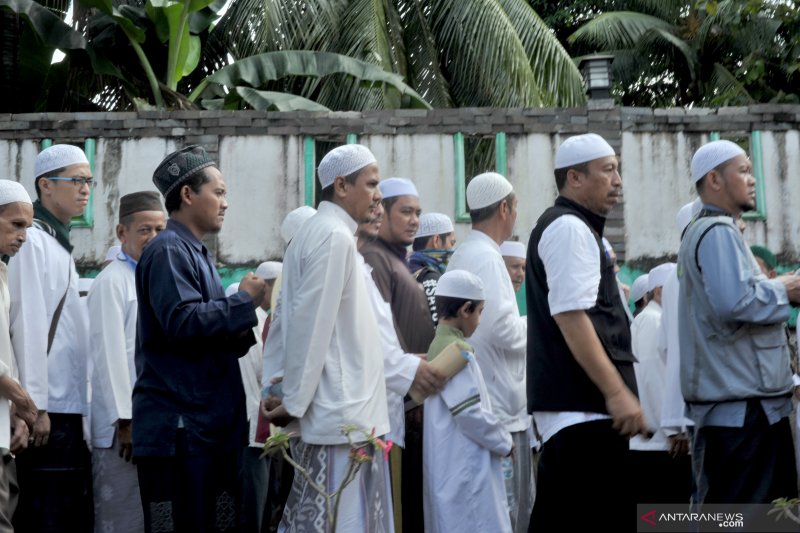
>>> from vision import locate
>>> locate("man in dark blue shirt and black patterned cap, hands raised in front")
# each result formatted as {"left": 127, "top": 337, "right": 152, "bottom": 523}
{"left": 132, "top": 146, "right": 266, "bottom": 533}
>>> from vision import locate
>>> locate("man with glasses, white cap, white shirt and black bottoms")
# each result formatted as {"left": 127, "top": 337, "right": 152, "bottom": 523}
{"left": 8, "top": 144, "right": 94, "bottom": 532}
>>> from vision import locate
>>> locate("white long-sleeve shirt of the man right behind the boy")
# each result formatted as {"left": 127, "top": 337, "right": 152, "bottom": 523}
{"left": 447, "top": 230, "right": 530, "bottom": 433}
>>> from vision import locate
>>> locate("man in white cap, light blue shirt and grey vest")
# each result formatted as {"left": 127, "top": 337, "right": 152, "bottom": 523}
{"left": 678, "top": 140, "right": 800, "bottom": 504}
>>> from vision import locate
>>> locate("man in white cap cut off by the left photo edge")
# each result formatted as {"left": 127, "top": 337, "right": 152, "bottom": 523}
{"left": 0, "top": 180, "right": 38, "bottom": 533}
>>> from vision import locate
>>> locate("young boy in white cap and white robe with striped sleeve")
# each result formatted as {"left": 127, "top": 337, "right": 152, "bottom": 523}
{"left": 423, "top": 270, "right": 510, "bottom": 533}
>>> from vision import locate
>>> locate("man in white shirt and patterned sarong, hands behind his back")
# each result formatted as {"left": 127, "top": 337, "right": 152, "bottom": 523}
{"left": 267, "top": 145, "right": 393, "bottom": 531}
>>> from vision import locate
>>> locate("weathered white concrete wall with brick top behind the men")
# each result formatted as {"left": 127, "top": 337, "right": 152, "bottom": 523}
{"left": 0, "top": 102, "right": 800, "bottom": 268}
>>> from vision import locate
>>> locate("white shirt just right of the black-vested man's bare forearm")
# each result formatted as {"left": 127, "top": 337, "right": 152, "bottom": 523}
{"left": 630, "top": 300, "right": 669, "bottom": 451}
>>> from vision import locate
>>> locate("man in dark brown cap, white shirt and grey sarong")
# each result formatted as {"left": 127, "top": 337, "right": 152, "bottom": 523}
{"left": 87, "top": 191, "right": 166, "bottom": 533}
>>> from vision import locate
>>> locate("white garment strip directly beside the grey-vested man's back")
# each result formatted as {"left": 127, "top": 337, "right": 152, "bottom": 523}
{"left": 658, "top": 272, "right": 694, "bottom": 436}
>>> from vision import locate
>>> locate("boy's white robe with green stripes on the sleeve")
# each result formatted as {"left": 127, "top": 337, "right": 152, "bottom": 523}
{"left": 422, "top": 359, "right": 512, "bottom": 533}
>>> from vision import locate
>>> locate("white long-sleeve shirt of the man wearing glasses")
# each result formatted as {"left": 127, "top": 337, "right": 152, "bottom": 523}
{"left": 8, "top": 228, "right": 89, "bottom": 416}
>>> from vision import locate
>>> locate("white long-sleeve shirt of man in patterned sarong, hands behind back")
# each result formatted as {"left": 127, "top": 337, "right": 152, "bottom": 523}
{"left": 280, "top": 202, "right": 389, "bottom": 445}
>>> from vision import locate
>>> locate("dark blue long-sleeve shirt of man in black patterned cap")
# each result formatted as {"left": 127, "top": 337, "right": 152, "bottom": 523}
{"left": 132, "top": 220, "right": 258, "bottom": 456}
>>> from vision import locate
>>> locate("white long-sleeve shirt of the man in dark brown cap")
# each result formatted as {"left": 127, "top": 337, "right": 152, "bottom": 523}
{"left": 86, "top": 257, "right": 138, "bottom": 448}
